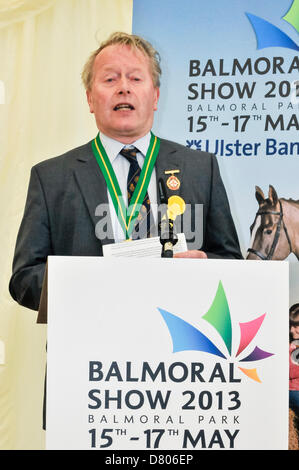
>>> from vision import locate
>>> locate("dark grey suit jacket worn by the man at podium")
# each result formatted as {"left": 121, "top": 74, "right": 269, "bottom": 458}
{"left": 9, "top": 139, "right": 242, "bottom": 310}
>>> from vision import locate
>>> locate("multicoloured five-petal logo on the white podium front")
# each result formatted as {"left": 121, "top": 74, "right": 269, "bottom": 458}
{"left": 158, "top": 281, "right": 273, "bottom": 382}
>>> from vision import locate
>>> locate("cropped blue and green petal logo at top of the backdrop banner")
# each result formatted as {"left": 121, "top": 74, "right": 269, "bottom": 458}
{"left": 246, "top": 0, "right": 299, "bottom": 51}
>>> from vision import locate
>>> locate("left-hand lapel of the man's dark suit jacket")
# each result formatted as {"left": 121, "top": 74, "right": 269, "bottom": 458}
{"left": 75, "top": 143, "right": 114, "bottom": 245}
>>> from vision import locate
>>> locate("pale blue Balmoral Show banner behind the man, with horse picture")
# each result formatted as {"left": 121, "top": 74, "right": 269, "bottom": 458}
{"left": 133, "top": 0, "right": 299, "bottom": 302}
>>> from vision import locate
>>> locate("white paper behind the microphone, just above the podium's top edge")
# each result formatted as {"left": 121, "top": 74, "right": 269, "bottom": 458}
{"left": 103, "top": 233, "right": 187, "bottom": 258}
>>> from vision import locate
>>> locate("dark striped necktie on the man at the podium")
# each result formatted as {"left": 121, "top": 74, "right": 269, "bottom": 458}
{"left": 120, "top": 147, "right": 154, "bottom": 240}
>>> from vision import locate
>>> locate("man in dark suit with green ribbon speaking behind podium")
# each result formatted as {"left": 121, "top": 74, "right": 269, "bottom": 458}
{"left": 9, "top": 33, "right": 242, "bottom": 310}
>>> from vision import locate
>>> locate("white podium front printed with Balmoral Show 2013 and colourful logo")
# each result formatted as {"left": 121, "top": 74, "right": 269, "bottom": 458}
{"left": 46, "top": 257, "right": 289, "bottom": 451}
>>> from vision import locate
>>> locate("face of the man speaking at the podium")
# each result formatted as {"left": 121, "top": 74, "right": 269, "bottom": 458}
{"left": 87, "top": 45, "right": 159, "bottom": 144}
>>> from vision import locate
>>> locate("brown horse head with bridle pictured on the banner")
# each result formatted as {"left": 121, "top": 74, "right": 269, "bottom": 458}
{"left": 246, "top": 185, "right": 291, "bottom": 260}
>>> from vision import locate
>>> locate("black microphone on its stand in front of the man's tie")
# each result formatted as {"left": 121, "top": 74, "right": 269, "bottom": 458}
{"left": 158, "top": 178, "right": 178, "bottom": 258}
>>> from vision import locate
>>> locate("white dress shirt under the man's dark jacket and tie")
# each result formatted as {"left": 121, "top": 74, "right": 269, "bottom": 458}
{"left": 100, "top": 132, "right": 157, "bottom": 242}
